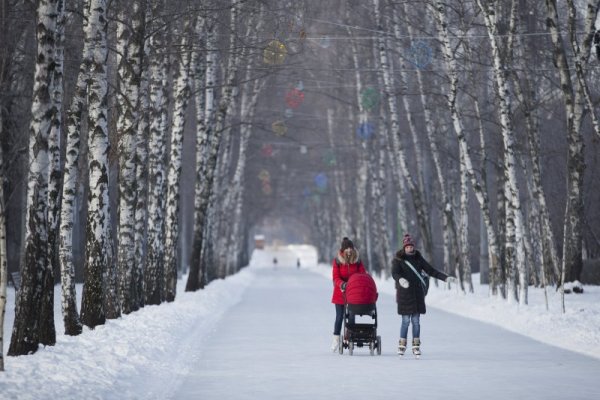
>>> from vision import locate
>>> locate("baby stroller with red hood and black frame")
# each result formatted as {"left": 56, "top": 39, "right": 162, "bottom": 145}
{"left": 339, "top": 274, "right": 381, "bottom": 355}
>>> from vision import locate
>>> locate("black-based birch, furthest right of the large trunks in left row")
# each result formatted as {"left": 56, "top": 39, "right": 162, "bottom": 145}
{"left": 185, "top": 18, "right": 218, "bottom": 292}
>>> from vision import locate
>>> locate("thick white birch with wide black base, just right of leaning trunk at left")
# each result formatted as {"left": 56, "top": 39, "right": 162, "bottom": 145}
{"left": 81, "top": 0, "right": 113, "bottom": 328}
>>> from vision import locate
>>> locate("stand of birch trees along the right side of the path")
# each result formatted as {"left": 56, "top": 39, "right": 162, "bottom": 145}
{"left": 292, "top": 0, "right": 600, "bottom": 310}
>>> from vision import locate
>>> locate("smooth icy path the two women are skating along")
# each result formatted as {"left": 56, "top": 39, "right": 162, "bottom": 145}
{"left": 174, "top": 262, "right": 600, "bottom": 400}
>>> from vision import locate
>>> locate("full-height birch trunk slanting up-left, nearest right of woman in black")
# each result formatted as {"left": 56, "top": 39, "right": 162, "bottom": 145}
{"left": 433, "top": 1, "right": 500, "bottom": 295}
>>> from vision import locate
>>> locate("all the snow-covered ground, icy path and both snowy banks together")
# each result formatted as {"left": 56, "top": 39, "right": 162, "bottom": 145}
{"left": 0, "top": 246, "right": 600, "bottom": 399}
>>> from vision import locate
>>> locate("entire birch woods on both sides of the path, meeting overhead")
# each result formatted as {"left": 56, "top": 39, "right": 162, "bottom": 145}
{"left": 0, "top": 0, "right": 600, "bottom": 368}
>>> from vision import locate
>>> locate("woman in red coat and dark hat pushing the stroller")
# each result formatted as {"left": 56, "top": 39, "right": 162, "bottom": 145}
{"left": 331, "top": 237, "right": 366, "bottom": 352}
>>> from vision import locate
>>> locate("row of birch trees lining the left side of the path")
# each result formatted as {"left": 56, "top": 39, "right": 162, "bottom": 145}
{"left": 0, "top": 0, "right": 300, "bottom": 364}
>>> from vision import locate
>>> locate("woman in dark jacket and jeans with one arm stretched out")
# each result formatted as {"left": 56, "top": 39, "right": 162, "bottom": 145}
{"left": 392, "top": 234, "right": 456, "bottom": 356}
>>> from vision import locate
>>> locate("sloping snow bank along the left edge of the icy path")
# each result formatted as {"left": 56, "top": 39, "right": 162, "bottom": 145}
{"left": 0, "top": 269, "right": 254, "bottom": 399}
